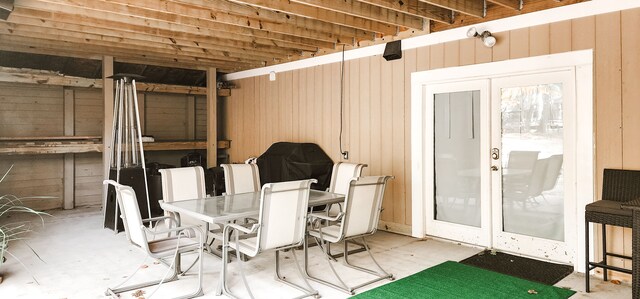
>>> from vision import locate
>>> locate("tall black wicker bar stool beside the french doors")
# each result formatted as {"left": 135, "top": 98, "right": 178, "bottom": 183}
{"left": 584, "top": 169, "right": 640, "bottom": 293}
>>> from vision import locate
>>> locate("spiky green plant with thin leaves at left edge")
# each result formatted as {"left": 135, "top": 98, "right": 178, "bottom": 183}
{"left": 0, "top": 165, "right": 52, "bottom": 283}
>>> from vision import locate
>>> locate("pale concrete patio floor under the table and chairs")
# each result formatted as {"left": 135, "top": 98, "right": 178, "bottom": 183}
{"left": 0, "top": 208, "right": 631, "bottom": 299}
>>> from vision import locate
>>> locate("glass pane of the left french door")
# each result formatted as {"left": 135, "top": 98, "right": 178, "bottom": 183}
{"left": 434, "top": 90, "right": 480, "bottom": 227}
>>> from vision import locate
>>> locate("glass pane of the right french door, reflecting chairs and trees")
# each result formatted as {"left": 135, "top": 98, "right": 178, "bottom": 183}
{"left": 500, "top": 83, "right": 564, "bottom": 241}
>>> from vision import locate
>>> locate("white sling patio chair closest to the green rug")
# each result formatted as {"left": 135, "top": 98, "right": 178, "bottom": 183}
{"left": 304, "top": 176, "right": 393, "bottom": 294}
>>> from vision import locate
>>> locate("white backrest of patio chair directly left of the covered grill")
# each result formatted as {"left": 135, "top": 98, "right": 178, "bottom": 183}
{"left": 220, "top": 164, "right": 260, "bottom": 194}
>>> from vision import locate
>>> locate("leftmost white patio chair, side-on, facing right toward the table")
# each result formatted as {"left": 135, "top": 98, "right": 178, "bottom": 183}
{"left": 104, "top": 180, "right": 204, "bottom": 299}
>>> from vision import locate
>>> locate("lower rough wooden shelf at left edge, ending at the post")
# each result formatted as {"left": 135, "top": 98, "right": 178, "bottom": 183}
{"left": 0, "top": 136, "right": 102, "bottom": 155}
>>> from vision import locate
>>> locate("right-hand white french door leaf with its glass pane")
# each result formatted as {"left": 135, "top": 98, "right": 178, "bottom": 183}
{"left": 491, "top": 70, "right": 575, "bottom": 263}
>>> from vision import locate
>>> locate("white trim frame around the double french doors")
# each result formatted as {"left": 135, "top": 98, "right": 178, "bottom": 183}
{"left": 411, "top": 50, "right": 595, "bottom": 272}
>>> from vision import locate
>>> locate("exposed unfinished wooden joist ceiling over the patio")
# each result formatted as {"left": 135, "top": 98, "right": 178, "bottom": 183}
{"left": 0, "top": 0, "right": 584, "bottom": 72}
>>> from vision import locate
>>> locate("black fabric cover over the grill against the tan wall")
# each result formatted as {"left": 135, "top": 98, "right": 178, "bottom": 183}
{"left": 256, "top": 142, "right": 333, "bottom": 190}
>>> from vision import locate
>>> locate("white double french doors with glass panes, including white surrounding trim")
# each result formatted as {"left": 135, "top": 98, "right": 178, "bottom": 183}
{"left": 412, "top": 52, "right": 593, "bottom": 270}
